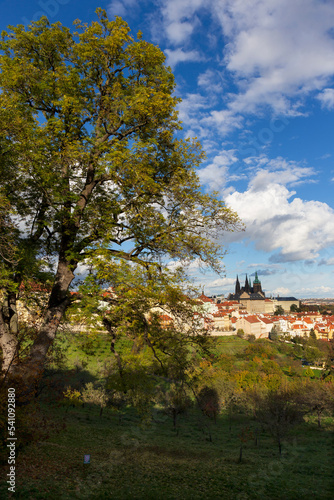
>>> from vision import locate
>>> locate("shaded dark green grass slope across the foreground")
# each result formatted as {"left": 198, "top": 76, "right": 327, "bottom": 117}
{"left": 0, "top": 404, "right": 334, "bottom": 500}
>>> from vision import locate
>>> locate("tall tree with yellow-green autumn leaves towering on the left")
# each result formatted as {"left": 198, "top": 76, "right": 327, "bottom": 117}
{"left": 0, "top": 9, "right": 239, "bottom": 382}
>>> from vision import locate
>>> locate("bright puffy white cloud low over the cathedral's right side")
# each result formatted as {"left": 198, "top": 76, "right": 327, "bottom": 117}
{"left": 225, "top": 162, "right": 334, "bottom": 264}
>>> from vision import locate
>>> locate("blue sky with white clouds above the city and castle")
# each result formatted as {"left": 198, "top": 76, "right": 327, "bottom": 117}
{"left": 0, "top": 0, "right": 334, "bottom": 298}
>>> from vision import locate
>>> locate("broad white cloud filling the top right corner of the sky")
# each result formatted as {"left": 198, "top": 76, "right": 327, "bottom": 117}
{"left": 212, "top": 0, "right": 334, "bottom": 114}
